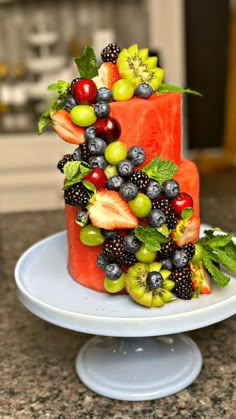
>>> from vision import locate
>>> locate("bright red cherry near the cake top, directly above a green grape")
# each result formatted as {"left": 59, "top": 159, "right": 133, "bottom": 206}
{"left": 71, "top": 79, "right": 97, "bottom": 105}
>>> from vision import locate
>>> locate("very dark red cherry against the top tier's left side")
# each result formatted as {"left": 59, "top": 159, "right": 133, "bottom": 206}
{"left": 93, "top": 117, "right": 121, "bottom": 143}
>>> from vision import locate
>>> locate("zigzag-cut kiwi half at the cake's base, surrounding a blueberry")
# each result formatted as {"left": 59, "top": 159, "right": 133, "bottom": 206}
{"left": 125, "top": 262, "right": 175, "bottom": 307}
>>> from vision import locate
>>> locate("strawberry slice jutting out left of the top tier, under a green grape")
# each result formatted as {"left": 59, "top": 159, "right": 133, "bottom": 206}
{"left": 51, "top": 109, "right": 85, "bottom": 144}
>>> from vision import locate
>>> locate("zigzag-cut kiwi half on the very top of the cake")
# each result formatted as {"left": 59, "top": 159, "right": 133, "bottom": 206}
{"left": 117, "top": 44, "right": 164, "bottom": 92}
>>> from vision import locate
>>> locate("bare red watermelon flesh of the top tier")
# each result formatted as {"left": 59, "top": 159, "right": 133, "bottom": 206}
{"left": 111, "top": 93, "right": 182, "bottom": 164}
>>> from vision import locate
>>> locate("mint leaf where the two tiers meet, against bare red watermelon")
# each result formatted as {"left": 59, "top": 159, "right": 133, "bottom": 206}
{"left": 142, "top": 156, "right": 178, "bottom": 184}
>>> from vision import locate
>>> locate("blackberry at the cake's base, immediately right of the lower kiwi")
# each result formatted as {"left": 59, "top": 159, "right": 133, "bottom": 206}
{"left": 169, "top": 266, "right": 193, "bottom": 300}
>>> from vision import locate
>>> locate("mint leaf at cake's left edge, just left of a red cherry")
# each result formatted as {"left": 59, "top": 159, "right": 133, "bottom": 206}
{"left": 64, "top": 160, "right": 92, "bottom": 189}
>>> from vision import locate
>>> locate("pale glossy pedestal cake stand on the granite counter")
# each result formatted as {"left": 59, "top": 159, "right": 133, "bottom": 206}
{"left": 15, "top": 226, "right": 236, "bottom": 401}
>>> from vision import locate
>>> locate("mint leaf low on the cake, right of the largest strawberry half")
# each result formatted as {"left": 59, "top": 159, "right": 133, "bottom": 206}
{"left": 134, "top": 225, "right": 169, "bottom": 252}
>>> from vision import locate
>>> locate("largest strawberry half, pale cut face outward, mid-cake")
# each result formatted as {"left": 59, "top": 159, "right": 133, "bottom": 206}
{"left": 89, "top": 190, "right": 138, "bottom": 230}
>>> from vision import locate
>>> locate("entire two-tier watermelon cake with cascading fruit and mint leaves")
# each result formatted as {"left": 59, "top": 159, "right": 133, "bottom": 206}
{"left": 39, "top": 44, "right": 236, "bottom": 307}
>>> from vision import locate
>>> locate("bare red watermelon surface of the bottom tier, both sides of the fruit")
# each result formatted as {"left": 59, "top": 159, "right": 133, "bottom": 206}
{"left": 65, "top": 160, "right": 199, "bottom": 292}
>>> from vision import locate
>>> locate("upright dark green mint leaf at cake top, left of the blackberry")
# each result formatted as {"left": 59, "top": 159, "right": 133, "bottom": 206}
{"left": 74, "top": 45, "right": 98, "bottom": 79}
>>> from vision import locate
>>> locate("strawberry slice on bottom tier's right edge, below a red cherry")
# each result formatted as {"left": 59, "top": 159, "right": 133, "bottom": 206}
{"left": 171, "top": 215, "right": 200, "bottom": 246}
